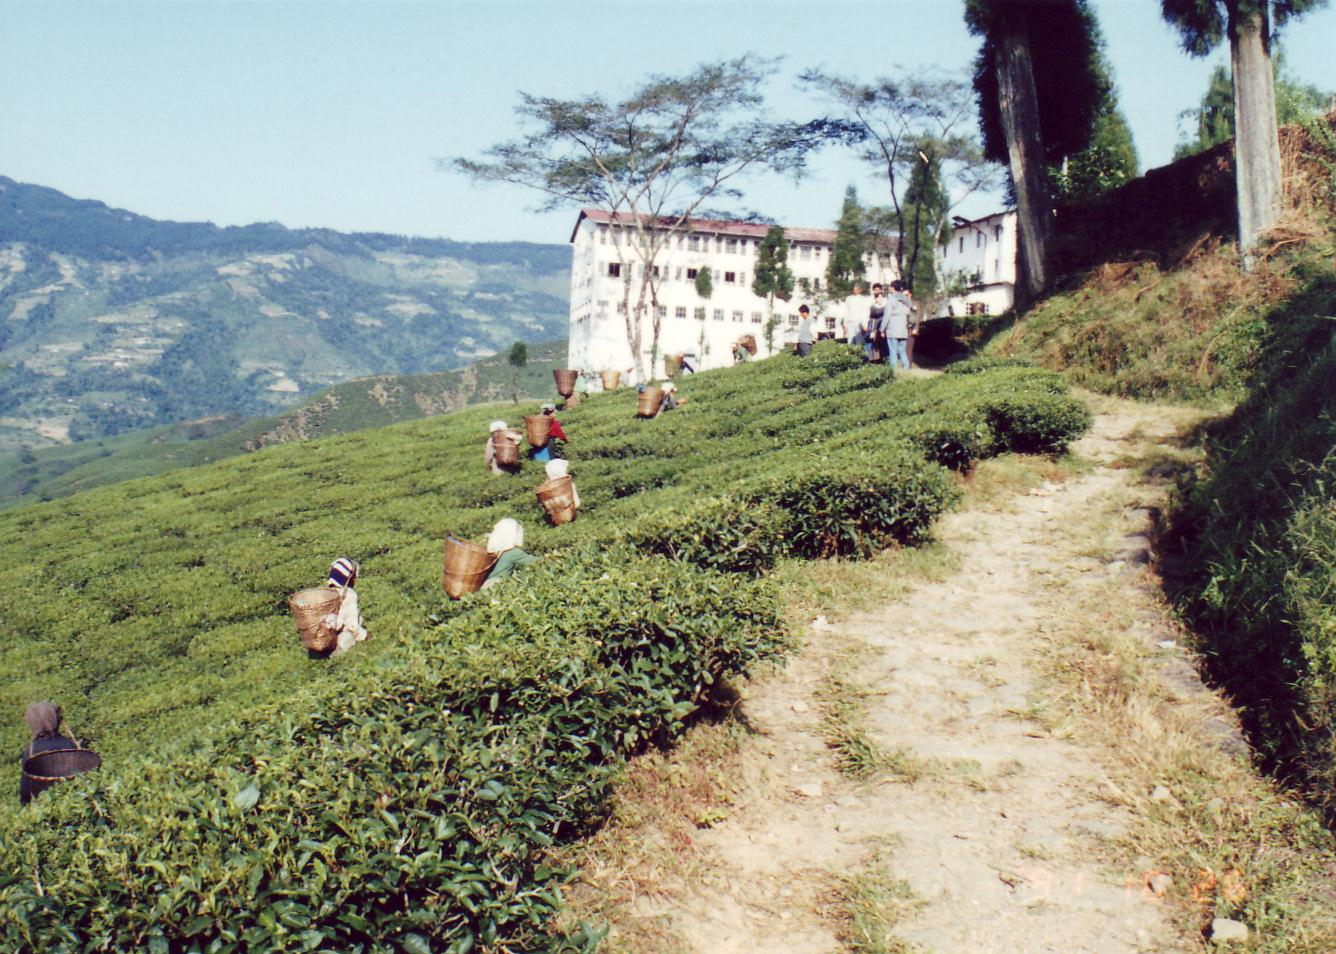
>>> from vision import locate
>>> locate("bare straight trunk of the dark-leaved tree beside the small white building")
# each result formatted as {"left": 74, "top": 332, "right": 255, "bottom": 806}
{"left": 997, "top": 16, "right": 1053, "bottom": 306}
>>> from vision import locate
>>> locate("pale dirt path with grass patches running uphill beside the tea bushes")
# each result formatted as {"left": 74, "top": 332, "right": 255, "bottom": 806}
{"left": 574, "top": 405, "right": 1223, "bottom": 954}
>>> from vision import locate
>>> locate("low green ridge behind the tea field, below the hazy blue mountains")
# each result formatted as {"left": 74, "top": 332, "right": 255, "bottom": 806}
{"left": 0, "top": 341, "right": 566, "bottom": 509}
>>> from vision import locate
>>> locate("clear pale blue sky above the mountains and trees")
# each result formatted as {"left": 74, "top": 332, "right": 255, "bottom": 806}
{"left": 0, "top": 0, "right": 1336, "bottom": 242}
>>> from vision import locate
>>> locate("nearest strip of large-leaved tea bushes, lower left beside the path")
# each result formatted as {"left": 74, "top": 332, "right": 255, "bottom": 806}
{"left": 0, "top": 550, "right": 783, "bottom": 954}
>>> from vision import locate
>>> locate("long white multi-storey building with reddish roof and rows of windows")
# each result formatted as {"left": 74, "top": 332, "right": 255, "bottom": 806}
{"left": 566, "top": 208, "right": 895, "bottom": 377}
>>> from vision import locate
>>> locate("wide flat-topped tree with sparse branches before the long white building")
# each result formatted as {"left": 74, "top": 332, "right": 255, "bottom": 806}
{"left": 454, "top": 55, "right": 824, "bottom": 379}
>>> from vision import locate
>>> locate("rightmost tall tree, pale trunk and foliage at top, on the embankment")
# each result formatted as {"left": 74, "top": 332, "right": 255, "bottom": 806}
{"left": 1160, "top": 0, "right": 1327, "bottom": 269}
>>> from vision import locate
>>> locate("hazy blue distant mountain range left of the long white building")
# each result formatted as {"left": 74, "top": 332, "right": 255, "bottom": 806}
{"left": 0, "top": 176, "right": 570, "bottom": 450}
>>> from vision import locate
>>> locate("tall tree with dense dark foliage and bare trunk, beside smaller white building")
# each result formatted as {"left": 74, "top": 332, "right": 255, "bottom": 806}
{"left": 965, "top": 0, "right": 1108, "bottom": 305}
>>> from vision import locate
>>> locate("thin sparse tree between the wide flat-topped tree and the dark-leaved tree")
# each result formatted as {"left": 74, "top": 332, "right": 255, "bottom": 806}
{"left": 800, "top": 71, "right": 997, "bottom": 293}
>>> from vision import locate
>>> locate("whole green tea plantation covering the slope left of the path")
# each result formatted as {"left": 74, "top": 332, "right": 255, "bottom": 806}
{"left": 0, "top": 345, "right": 1089, "bottom": 954}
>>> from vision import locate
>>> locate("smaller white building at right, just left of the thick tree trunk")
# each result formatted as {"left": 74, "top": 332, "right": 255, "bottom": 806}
{"left": 937, "top": 212, "right": 1017, "bottom": 315}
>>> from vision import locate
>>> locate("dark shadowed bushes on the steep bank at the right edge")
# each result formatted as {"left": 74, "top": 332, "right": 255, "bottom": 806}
{"left": 1165, "top": 248, "right": 1336, "bottom": 816}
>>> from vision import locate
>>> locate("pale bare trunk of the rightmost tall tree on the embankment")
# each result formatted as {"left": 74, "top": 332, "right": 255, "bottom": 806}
{"left": 1229, "top": 3, "right": 1281, "bottom": 270}
